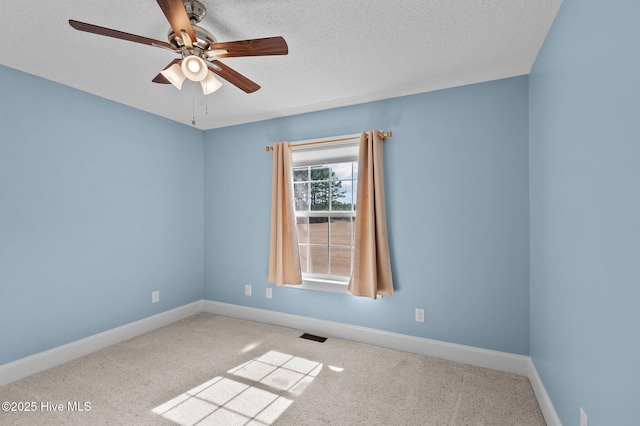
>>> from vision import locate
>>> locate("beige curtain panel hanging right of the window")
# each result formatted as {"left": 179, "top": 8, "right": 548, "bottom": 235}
{"left": 348, "top": 130, "right": 393, "bottom": 299}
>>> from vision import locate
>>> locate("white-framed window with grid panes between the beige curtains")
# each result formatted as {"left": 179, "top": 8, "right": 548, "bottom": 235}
{"left": 292, "top": 140, "right": 358, "bottom": 291}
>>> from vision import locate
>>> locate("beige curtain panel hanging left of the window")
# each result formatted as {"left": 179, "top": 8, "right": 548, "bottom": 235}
{"left": 267, "top": 142, "right": 302, "bottom": 285}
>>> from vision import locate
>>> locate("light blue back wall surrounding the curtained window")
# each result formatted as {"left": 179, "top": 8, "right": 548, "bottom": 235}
{"left": 204, "top": 76, "right": 529, "bottom": 354}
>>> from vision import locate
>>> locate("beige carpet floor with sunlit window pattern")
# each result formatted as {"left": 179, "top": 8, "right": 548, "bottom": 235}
{"left": 0, "top": 313, "right": 545, "bottom": 426}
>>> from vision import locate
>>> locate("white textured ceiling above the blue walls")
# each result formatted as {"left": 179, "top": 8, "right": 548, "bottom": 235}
{"left": 0, "top": 0, "right": 561, "bottom": 129}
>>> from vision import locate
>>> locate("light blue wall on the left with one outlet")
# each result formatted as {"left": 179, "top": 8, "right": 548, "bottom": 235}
{"left": 0, "top": 66, "right": 203, "bottom": 364}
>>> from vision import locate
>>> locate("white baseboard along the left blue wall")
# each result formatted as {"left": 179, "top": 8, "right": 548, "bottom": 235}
{"left": 0, "top": 300, "right": 203, "bottom": 386}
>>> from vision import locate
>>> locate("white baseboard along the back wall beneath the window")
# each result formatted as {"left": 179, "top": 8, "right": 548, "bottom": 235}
{"left": 203, "top": 300, "right": 530, "bottom": 376}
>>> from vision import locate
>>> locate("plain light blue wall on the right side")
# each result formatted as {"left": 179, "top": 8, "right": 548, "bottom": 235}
{"left": 530, "top": 0, "right": 640, "bottom": 426}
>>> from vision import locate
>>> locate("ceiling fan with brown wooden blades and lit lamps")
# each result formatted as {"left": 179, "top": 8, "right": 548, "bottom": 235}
{"left": 69, "top": 0, "right": 289, "bottom": 95}
